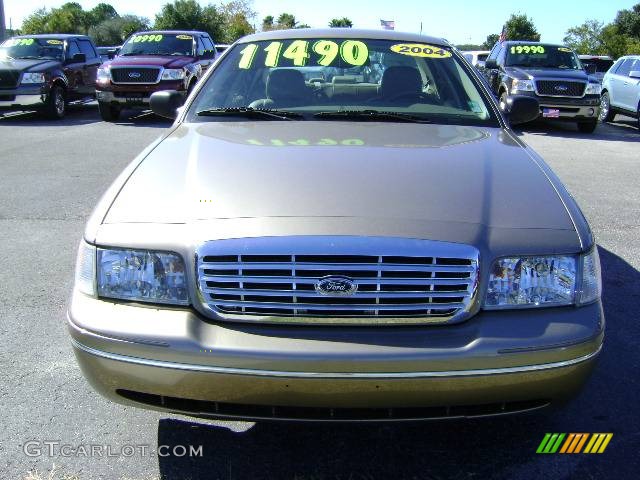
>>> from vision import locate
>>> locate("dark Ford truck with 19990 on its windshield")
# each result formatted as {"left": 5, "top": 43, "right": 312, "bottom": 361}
{"left": 482, "top": 41, "right": 601, "bottom": 133}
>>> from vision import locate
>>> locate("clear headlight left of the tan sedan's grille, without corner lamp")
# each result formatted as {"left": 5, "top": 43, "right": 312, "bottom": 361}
{"left": 96, "top": 248, "right": 189, "bottom": 305}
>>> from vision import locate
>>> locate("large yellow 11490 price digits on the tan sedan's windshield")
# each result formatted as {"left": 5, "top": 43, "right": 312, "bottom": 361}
{"left": 238, "top": 40, "right": 369, "bottom": 70}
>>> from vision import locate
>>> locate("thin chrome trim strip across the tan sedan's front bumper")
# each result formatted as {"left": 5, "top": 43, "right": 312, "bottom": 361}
{"left": 71, "top": 338, "right": 602, "bottom": 379}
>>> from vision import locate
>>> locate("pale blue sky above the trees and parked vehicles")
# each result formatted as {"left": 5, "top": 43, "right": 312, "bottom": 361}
{"left": 4, "top": 0, "right": 640, "bottom": 44}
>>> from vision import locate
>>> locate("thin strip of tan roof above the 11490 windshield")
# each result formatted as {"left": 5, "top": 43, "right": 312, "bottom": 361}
{"left": 239, "top": 28, "right": 451, "bottom": 47}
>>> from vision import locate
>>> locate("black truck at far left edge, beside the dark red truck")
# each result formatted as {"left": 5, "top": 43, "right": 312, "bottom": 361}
{"left": 0, "top": 35, "right": 100, "bottom": 119}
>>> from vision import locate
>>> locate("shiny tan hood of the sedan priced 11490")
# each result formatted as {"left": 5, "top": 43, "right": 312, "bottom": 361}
{"left": 102, "top": 121, "right": 579, "bottom": 248}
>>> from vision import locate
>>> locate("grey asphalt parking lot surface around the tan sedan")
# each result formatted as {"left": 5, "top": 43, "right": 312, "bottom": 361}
{"left": 0, "top": 105, "right": 640, "bottom": 480}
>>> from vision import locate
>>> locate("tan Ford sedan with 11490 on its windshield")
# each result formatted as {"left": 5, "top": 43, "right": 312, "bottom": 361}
{"left": 68, "top": 29, "right": 604, "bottom": 420}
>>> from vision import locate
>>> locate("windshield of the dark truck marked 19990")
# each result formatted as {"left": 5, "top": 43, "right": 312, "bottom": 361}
{"left": 506, "top": 44, "right": 582, "bottom": 70}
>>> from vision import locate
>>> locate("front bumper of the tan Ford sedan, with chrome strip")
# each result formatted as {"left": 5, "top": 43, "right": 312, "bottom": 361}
{"left": 68, "top": 293, "right": 604, "bottom": 420}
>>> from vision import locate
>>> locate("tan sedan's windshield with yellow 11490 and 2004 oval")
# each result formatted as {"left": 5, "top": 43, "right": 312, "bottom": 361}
{"left": 186, "top": 37, "right": 497, "bottom": 125}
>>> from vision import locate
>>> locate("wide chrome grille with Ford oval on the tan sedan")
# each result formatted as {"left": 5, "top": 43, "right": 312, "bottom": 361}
{"left": 197, "top": 237, "right": 478, "bottom": 324}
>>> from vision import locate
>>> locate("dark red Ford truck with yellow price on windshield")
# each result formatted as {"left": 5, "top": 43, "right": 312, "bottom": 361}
{"left": 96, "top": 31, "right": 217, "bottom": 121}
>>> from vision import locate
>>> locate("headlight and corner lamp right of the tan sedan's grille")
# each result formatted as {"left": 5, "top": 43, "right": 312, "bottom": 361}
{"left": 484, "top": 248, "right": 602, "bottom": 309}
